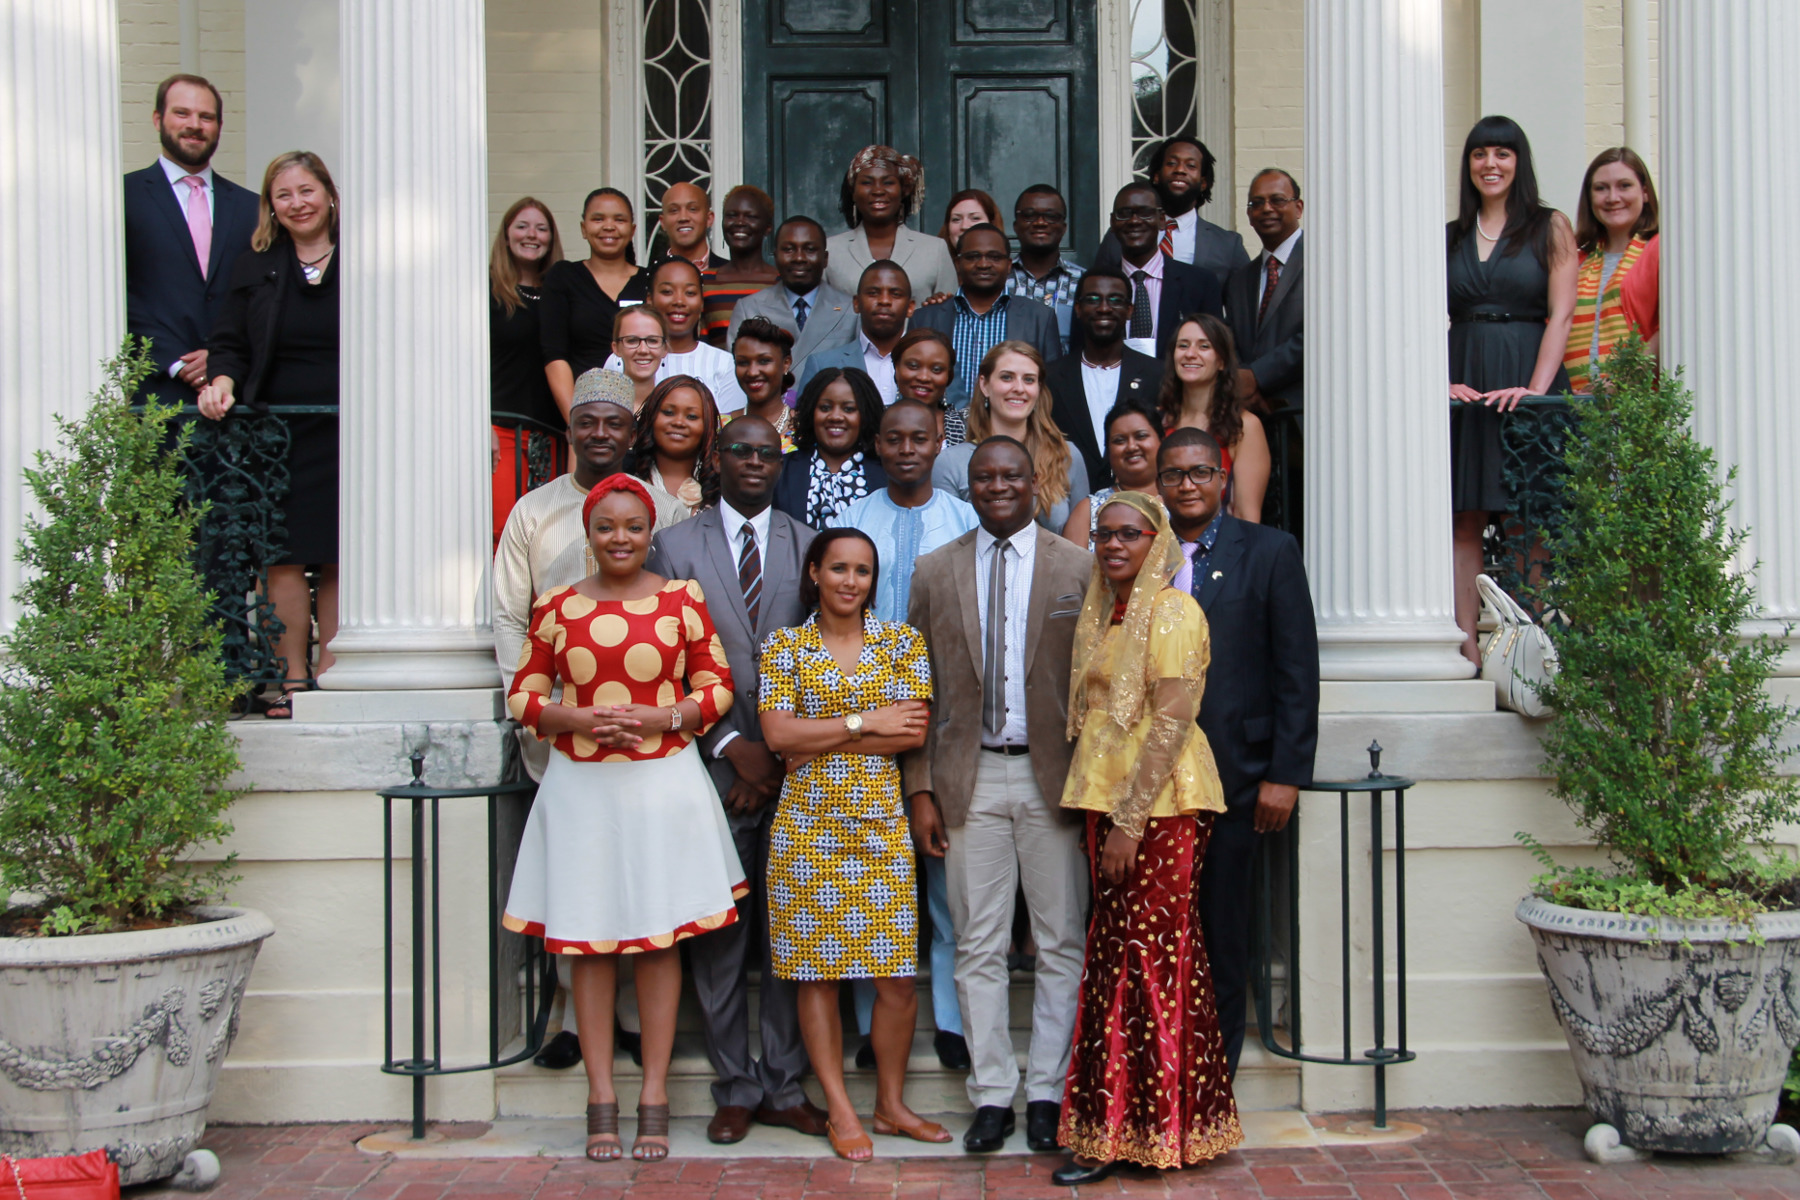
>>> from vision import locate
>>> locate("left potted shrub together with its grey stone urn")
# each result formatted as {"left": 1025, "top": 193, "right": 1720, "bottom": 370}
{"left": 0, "top": 349, "right": 274, "bottom": 1184}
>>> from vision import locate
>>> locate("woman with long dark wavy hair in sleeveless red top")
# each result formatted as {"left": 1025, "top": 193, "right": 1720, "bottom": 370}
{"left": 1156, "top": 313, "right": 1273, "bottom": 525}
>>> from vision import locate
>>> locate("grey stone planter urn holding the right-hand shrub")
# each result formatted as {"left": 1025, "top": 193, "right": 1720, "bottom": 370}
{"left": 1516, "top": 896, "right": 1800, "bottom": 1162}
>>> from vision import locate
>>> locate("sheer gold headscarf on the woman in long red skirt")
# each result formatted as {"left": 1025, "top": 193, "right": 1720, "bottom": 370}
{"left": 1069, "top": 491, "right": 1186, "bottom": 741}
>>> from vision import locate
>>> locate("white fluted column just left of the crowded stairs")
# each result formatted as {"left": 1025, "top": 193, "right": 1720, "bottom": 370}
{"left": 320, "top": 0, "right": 499, "bottom": 691}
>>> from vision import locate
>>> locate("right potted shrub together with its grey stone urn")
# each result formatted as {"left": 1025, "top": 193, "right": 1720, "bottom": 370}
{"left": 1517, "top": 344, "right": 1800, "bottom": 1159}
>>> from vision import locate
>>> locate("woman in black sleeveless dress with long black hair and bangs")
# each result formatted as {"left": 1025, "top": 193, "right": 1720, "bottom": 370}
{"left": 1445, "top": 117, "right": 1579, "bottom": 662}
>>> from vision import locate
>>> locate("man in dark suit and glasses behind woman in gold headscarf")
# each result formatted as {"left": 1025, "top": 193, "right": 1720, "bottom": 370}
{"left": 1156, "top": 428, "right": 1319, "bottom": 1072}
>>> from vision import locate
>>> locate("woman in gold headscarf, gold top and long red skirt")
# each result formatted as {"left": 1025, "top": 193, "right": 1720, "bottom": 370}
{"left": 1053, "top": 491, "right": 1244, "bottom": 1186}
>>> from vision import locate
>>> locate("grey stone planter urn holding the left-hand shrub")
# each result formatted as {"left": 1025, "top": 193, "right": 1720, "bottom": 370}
{"left": 0, "top": 907, "right": 275, "bottom": 1184}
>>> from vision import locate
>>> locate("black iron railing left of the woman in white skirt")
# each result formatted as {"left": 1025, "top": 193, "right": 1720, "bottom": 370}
{"left": 380, "top": 750, "right": 556, "bottom": 1141}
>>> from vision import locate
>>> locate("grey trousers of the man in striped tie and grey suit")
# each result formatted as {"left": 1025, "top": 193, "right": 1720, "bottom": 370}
{"left": 688, "top": 804, "right": 808, "bottom": 1108}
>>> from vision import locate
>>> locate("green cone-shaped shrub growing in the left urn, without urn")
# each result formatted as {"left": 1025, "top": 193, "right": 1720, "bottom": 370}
{"left": 0, "top": 342, "right": 239, "bottom": 934}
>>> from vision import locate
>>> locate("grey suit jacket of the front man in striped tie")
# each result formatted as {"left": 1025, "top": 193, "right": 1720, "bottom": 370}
{"left": 644, "top": 506, "right": 812, "bottom": 799}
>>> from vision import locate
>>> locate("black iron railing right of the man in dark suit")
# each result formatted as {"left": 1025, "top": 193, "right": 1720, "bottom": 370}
{"left": 1251, "top": 743, "right": 1417, "bottom": 1130}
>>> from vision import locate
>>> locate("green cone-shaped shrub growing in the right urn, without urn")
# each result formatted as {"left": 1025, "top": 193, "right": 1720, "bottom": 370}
{"left": 1537, "top": 340, "right": 1800, "bottom": 916}
